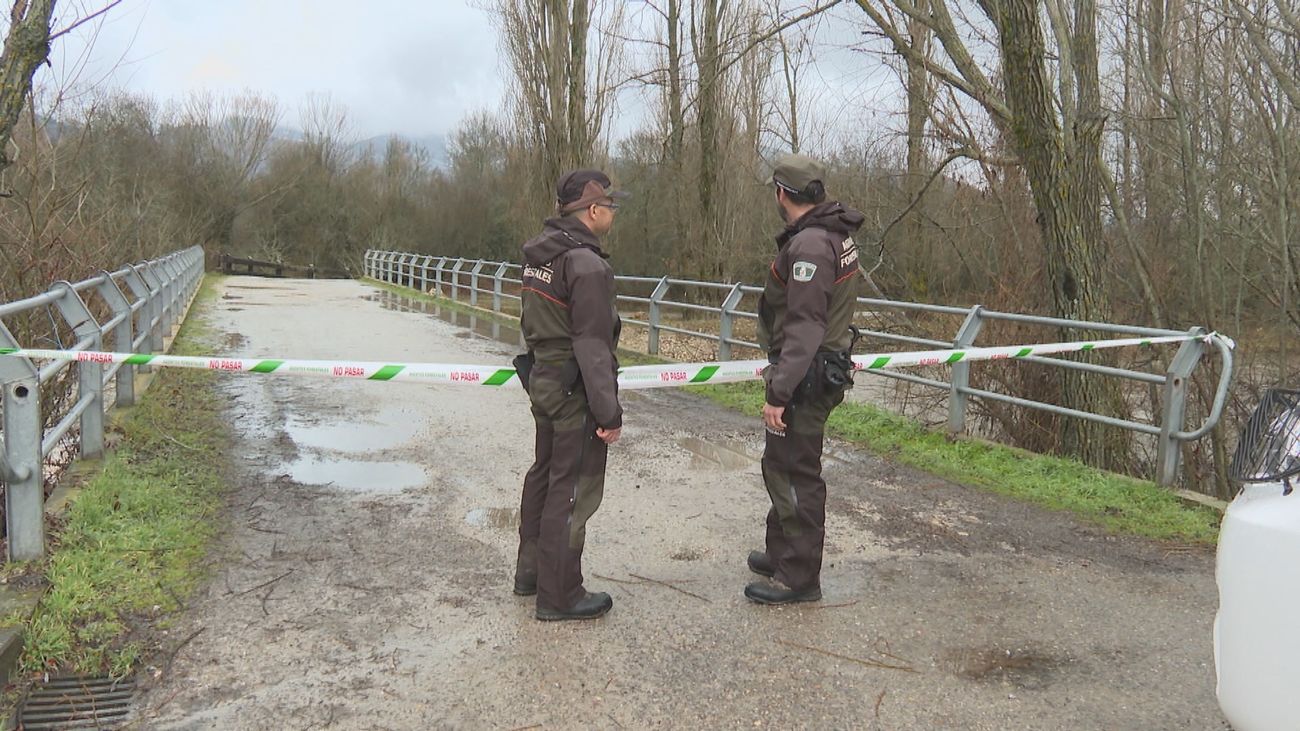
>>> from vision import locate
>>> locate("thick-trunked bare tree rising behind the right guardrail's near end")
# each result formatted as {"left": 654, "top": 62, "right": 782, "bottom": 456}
{"left": 857, "top": 0, "right": 1127, "bottom": 464}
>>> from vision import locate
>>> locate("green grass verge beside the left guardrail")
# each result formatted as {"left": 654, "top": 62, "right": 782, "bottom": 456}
{"left": 21, "top": 277, "right": 229, "bottom": 675}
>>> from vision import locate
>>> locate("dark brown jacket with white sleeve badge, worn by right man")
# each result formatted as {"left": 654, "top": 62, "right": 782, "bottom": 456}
{"left": 758, "top": 203, "right": 865, "bottom": 406}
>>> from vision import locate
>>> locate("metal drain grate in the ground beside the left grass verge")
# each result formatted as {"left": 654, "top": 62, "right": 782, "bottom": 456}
{"left": 18, "top": 678, "right": 135, "bottom": 731}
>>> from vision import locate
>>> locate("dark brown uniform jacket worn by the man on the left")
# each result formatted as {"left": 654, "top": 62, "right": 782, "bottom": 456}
{"left": 520, "top": 216, "right": 623, "bottom": 429}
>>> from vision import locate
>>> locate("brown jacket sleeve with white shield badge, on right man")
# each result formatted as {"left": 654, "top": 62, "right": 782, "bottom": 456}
{"left": 767, "top": 232, "right": 836, "bottom": 406}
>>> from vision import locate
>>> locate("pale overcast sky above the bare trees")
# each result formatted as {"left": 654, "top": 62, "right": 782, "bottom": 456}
{"left": 42, "top": 0, "right": 893, "bottom": 148}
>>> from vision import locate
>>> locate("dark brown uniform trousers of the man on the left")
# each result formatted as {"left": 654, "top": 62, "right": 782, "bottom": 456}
{"left": 516, "top": 363, "right": 607, "bottom": 610}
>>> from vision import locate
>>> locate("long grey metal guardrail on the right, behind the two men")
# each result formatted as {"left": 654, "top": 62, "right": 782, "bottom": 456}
{"left": 363, "top": 250, "right": 1232, "bottom": 485}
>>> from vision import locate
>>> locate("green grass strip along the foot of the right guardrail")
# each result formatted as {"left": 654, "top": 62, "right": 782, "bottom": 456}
{"left": 365, "top": 280, "right": 1222, "bottom": 545}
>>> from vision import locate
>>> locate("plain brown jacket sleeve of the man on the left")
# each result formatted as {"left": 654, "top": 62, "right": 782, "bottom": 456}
{"left": 569, "top": 260, "right": 623, "bottom": 429}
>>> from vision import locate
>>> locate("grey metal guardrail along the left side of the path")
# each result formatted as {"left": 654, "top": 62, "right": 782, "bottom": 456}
{"left": 0, "top": 246, "right": 203, "bottom": 561}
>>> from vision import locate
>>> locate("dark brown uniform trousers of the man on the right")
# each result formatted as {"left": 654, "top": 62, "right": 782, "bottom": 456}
{"left": 763, "top": 377, "right": 844, "bottom": 591}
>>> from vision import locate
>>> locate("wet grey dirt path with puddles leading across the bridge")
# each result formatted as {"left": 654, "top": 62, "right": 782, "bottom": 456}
{"left": 138, "top": 278, "right": 1222, "bottom": 730}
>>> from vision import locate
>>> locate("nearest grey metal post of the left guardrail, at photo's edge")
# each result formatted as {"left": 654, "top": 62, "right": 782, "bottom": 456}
{"left": 0, "top": 323, "right": 46, "bottom": 561}
